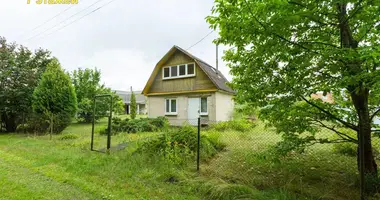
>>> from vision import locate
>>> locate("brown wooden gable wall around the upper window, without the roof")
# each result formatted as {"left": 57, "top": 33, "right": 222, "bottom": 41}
{"left": 144, "top": 50, "right": 217, "bottom": 95}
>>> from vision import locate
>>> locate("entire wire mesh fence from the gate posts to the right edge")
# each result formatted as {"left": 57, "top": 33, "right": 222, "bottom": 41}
{"left": 87, "top": 117, "right": 380, "bottom": 199}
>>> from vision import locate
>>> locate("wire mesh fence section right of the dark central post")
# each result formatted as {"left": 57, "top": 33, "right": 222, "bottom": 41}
{"left": 197, "top": 119, "right": 380, "bottom": 199}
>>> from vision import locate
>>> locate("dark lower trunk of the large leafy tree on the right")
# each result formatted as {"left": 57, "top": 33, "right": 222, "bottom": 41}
{"left": 351, "top": 89, "right": 377, "bottom": 176}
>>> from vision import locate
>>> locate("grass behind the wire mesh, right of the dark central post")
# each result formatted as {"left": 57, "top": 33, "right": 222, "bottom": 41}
{"left": 201, "top": 122, "right": 378, "bottom": 200}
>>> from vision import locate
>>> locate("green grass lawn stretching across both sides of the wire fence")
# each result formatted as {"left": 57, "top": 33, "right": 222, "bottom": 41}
{"left": 0, "top": 120, "right": 378, "bottom": 200}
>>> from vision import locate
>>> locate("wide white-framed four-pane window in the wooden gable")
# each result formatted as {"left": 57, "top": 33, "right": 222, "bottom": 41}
{"left": 162, "top": 63, "right": 195, "bottom": 79}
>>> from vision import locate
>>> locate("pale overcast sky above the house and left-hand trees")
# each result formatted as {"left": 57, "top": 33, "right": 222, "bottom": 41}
{"left": 0, "top": 0, "right": 231, "bottom": 90}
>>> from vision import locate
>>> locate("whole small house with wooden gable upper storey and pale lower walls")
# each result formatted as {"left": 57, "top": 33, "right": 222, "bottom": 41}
{"left": 142, "top": 46, "right": 235, "bottom": 125}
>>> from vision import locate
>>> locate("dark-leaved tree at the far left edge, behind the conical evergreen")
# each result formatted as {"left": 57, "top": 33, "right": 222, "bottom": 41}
{"left": 0, "top": 37, "right": 51, "bottom": 132}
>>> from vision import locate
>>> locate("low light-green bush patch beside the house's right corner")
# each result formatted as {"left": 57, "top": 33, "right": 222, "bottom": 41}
{"left": 211, "top": 119, "right": 254, "bottom": 132}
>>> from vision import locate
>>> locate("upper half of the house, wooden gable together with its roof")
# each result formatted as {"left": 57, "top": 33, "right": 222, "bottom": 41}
{"left": 142, "top": 46, "right": 235, "bottom": 96}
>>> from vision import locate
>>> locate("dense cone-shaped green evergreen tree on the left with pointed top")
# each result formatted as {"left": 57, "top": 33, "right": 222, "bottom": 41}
{"left": 33, "top": 59, "right": 77, "bottom": 139}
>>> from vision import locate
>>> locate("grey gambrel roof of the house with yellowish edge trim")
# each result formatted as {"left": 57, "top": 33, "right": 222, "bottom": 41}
{"left": 142, "top": 46, "right": 235, "bottom": 94}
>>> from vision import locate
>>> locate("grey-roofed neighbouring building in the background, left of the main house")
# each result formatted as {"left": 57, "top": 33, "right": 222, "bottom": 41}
{"left": 115, "top": 90, "right": 147, "bottom": 115}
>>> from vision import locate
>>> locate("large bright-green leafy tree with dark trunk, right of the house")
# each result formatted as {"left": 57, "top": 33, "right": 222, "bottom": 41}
{"left": 207, "top": 0, "right": 380, "bottom": 175}
